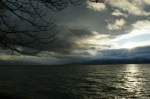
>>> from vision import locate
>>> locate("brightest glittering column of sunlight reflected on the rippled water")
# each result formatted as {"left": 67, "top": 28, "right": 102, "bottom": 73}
{"left": 119, "top": 64, "right": 145, "bottom": 96}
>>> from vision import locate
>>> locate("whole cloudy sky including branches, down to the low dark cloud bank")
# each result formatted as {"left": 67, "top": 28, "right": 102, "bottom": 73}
{"left": 0, "top": 0, "right": 150, "bottom": 62}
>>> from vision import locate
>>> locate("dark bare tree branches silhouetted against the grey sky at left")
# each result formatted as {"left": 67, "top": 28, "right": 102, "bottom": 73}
{"left": 0, "top": 0, "right": 94, "bottom": 54}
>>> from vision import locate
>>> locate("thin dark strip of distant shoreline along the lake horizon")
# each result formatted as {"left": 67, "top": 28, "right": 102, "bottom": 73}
{"left": 0, "top": 60, "right": 150, "bottom": 66}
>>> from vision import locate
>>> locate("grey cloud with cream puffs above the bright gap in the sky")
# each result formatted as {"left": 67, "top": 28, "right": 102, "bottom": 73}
{"left": 58, "top": 0, "right": 150, "bottom": 35}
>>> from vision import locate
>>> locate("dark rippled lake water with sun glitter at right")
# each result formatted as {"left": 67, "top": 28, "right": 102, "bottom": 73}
{"left": 0, "top": 64, "right": 150, "bottom": 99}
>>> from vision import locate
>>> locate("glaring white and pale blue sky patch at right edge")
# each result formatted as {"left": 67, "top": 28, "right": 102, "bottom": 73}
{"left": 112, "top": 27, "right": 150, "bottom": 49}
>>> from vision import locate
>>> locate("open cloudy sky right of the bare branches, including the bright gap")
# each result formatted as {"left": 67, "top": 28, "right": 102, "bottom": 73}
{"left": 0, "top": 0, "right": 150, "bottom": 62}
